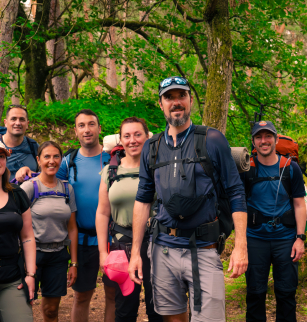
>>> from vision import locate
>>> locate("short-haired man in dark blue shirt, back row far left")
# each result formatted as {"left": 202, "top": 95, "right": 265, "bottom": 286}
{"left": 0, "top": 105, "right": 39, "bottom": 180}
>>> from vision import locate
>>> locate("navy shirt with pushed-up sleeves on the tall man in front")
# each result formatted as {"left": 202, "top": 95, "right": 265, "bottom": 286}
{"left": 136, "top": 125, "right": 246, "bottom": 248}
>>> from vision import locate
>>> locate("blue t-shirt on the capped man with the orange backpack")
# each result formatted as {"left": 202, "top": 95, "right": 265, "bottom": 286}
{"left": 241, "top": 156, "right": 306, "bottom": 240}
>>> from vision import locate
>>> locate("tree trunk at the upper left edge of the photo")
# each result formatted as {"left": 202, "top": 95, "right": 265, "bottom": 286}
{"left": 0, "top": 0, "right": 19, "bottom": 119}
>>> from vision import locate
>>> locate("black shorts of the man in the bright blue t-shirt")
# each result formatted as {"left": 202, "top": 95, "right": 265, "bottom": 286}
{"left": 72, "top": 245, "right": 99, "bottom": 293}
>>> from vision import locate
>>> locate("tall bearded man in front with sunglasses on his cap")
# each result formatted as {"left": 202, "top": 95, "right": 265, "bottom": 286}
{"left": 129, "top": 76, "right": 248, "bottom": 322}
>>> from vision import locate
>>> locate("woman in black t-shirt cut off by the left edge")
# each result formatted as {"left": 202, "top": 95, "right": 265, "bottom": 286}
{"left": 0, "top": 142, "right": 36, "bottom": 322}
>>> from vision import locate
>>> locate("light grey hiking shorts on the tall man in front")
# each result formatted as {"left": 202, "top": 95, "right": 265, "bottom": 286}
{"left": 148, "top": 243, "right": 225, "bottom": 322}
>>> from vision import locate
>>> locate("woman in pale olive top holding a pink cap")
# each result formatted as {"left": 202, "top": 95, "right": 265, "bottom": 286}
{"left": 96, "top": 117, "right": 162, "bottom": 322}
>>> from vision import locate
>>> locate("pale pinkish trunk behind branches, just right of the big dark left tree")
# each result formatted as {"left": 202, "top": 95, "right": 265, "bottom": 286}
{"left": 46, "top": 0, "right": 69, "bottom": 101}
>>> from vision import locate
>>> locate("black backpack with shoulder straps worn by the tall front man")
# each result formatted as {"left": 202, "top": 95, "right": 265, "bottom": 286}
{"left": 149, "top": 125, "right": 233, "bottom": 238}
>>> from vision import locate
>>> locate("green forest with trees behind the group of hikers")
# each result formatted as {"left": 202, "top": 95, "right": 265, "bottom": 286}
{"left": 0, "top": 0, "right": 307, "bottom": 321}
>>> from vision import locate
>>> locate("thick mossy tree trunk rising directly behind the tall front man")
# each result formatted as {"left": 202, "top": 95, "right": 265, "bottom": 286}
{"left": 203, "top": 0, "right": 233, "bottom": 134}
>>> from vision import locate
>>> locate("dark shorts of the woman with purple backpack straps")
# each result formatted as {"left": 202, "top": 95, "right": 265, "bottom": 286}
{"left": 35, "top": 247, "right": 70, "bottom": 299}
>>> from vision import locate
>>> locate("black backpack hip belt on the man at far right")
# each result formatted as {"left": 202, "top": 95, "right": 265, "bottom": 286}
{"left": 247, "top": 207, "right": 296, "bottom": 228}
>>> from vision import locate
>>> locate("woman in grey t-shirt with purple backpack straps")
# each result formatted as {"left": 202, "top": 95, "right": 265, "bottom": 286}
{"left": 21, "top": 141, "right": 78, "bottom": 322}
